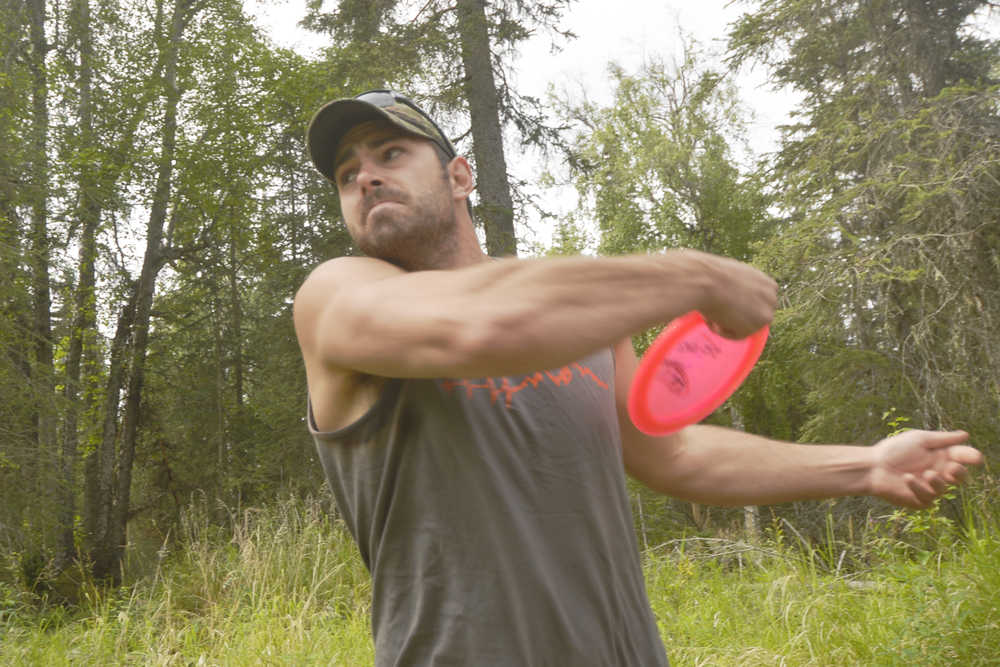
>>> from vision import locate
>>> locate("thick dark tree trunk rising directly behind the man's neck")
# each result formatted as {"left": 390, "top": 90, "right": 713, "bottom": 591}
{"left": 456, "top": 0, "right": 517, "bottom": 257}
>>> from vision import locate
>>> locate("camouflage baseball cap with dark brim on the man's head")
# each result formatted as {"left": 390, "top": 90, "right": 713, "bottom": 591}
{"left": 306, "top": 90, "right": 456, "bottom": 182}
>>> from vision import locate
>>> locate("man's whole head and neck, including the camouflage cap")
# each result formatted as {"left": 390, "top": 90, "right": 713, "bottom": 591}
{"left": 306, "top": 91, "right": 480, "bottom": 270}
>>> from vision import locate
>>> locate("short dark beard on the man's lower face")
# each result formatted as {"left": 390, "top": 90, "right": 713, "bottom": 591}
{"left": 358, "top": 181, "right": 458, "bottom": 271}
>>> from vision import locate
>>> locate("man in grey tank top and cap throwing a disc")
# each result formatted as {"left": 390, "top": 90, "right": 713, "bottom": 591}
{"left": 295, "top": 91, "right": 981, "bottom": 666}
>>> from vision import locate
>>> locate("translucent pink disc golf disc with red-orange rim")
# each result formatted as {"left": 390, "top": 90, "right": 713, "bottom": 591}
{"left": 628, "top": 311, "right": 769, "bottom": 435}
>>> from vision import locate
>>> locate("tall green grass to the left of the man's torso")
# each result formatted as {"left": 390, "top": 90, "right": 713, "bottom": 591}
{"left": 0, "top": 498, "right": 373, "bottom": 665}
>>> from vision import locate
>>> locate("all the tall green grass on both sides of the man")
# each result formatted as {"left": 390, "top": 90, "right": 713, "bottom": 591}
{"left": 0, "top": 488, "right": 1000, "bottom": 667}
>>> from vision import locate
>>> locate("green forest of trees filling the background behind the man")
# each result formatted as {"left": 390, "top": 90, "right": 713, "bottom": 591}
{"left": 0, "top": 0, "right": 1000, "bottom": 664}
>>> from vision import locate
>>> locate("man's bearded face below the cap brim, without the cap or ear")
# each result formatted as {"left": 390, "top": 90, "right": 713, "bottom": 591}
{"left": 334, "top": 121, "right": 456, "bottom": 270}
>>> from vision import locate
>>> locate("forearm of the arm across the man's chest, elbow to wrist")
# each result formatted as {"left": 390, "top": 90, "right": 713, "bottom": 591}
{"left": 438, "top": 253, "right": 714, "bottom": 373}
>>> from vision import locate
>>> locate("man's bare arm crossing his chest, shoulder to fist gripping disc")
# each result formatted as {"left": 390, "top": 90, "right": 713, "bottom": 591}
{"left": 295, "top": 250, "right": 776, "bottom": 377}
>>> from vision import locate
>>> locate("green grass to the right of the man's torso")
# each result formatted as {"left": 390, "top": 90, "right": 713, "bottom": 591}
{"left": 645, "top": 488, "right": 1000, "bottom": 667}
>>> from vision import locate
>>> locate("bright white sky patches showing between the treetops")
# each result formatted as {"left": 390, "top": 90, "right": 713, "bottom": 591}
{"left": 246, "top": 0, "right": 1000, "bottom": 249}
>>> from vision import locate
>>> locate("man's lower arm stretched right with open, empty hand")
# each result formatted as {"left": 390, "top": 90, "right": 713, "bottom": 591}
{"left": 615, "top": 340, "right": 983, "bottom": 508}
